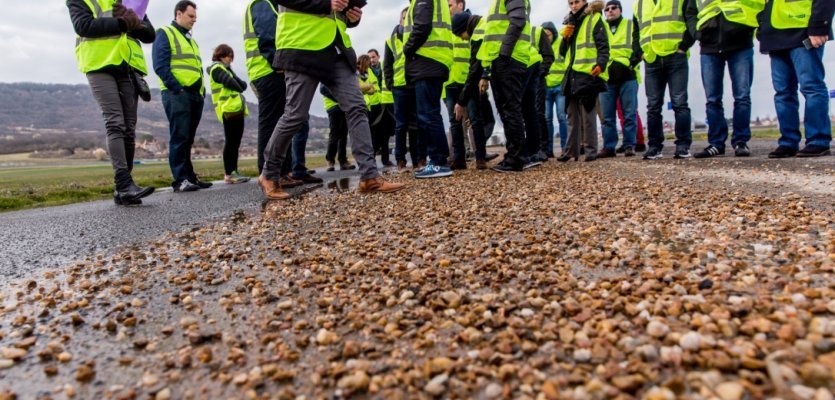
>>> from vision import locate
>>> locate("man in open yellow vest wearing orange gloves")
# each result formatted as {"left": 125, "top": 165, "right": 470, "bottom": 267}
{"left": 557, "top": 0, "right": 611, "bottom": 162}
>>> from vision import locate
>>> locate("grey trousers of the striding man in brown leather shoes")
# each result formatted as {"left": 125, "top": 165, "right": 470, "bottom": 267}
{"left": 263, "top": 62, "right": 380, "bottom": 180}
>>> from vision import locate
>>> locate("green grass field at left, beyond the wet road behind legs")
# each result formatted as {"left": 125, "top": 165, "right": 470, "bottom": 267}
{"left": 0, "top": 155, "right": 325, "bottom": 212}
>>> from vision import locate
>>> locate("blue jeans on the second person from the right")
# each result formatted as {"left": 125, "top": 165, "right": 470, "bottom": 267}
{"left": 704, "top": 49, "right": 754, "bottom": 149}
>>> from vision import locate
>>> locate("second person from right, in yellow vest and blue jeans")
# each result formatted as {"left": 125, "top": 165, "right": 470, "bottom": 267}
{"left": 685, "top": 0, "right": 765, "bottom": 158}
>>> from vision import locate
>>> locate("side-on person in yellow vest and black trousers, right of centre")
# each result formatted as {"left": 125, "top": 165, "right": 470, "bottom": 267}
{"left": 478, "top": 0, "right": 531, "bottom": 172}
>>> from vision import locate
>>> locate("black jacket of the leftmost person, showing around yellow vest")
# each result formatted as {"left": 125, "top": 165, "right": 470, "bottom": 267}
{"left": 67, "top": 0, "right": 157, "bottom": 73}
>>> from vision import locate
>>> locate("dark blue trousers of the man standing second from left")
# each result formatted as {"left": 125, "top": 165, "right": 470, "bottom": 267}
{"left": 162, "top": 90, "right": 203, "bottom": 187}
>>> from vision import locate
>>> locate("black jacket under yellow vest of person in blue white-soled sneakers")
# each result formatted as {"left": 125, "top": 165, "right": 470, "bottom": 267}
{"left": 403, "top": 0, "right": 449, "bottom": 82}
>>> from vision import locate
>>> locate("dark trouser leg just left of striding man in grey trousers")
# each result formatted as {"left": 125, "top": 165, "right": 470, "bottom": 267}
{"left": 252, "top": 73, "right": 287, "bottom": 173}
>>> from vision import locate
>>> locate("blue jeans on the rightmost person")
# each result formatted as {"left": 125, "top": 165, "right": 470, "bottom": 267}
{"left": 769, "top": 46, "right": 832, "bottom": 149}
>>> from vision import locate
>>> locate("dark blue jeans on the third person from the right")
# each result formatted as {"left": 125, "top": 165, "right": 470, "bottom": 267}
{"left": 646, "top": 52, "right": 693, "bottom": 149}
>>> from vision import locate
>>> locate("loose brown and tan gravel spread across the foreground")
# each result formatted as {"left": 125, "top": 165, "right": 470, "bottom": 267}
{"left": 0, "top": 163, "right": 835, "bottom": 400}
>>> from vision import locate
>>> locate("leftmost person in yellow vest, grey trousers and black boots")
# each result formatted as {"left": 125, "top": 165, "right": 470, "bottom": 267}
{"left": 67, "top": 0, "right": 154, "bottom": 205}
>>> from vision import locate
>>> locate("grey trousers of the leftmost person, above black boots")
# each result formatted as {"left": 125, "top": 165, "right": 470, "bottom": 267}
{"left": 87, "top": 72, "right": 139, "bottom": 190}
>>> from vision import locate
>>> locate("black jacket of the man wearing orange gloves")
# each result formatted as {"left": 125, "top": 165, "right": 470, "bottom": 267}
{"left": 560, "top": 2, "right": 609, "bottom": 98}
